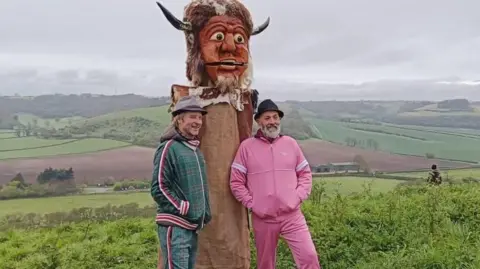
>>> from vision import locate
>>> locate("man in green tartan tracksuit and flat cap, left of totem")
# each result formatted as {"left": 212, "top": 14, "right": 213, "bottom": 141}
{"left": 151, "top": 97, "right": 211, "bottom": 269}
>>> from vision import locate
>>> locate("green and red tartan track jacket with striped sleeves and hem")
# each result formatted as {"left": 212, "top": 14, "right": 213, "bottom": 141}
{"left": 151, "top": 129, "right": 212, "bottom": 230}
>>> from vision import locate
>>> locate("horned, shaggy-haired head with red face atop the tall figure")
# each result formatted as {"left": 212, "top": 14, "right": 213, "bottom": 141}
{"left": 157, "top": 0, "right": 270, "bottom": 92}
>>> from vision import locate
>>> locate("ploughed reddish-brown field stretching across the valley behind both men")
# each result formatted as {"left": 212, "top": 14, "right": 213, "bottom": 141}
{"left": 0, "top": 140, "right": 468, "bottom": 184}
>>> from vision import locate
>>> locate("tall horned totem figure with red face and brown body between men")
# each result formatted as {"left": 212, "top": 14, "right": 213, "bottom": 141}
{"left": 157, "top": 0, "right": 270, "bottom": 269}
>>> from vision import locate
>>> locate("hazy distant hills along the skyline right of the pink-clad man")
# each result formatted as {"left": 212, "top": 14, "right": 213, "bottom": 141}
{"left": 286, "top": 99, "right": 480, "bottom": 130}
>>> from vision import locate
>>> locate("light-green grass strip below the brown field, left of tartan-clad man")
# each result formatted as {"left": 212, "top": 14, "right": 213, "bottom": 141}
{"left": 0, "top": 192, "right": 153, "bottom": 217}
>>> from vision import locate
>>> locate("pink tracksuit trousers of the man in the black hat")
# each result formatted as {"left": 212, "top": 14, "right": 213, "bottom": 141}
{"left": 252, "top": 210, "right": 320, "bottom": 269}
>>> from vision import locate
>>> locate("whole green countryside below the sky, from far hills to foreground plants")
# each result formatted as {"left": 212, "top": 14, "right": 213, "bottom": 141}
{"left": 0, "top": 94, "right": 480, "bottom": 269}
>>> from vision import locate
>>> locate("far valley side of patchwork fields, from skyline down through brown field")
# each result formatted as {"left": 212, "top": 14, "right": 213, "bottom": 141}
{"left": 0, "top": 92, "right": 480, "bottom": 184}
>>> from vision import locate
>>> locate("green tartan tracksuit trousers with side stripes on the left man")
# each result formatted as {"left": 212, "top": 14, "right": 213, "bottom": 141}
{"left": 157, "top": 225, "right": 198, "bottom": 269}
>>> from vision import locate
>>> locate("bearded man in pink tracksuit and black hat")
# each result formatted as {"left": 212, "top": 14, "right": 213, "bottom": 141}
{"left": 230, "top": 99, "right": 320, "bottom": 269}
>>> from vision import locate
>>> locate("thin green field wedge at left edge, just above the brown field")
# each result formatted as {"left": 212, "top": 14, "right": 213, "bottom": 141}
{"left": 0, "top": 137, "right": 74, "bottom": 152}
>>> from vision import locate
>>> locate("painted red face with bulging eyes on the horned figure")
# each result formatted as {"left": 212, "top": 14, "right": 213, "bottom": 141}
{"left": 199, "top": 16, "right": 249, "bottom": 82}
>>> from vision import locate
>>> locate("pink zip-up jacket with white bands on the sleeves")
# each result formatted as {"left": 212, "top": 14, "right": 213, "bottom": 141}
{"left": 230, "top": 133, "right": 312, "bottom": 219}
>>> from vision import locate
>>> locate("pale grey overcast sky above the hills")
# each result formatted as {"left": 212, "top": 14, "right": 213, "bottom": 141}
{"left": 0, "top": 0, "right": 480, "bottom": 98}
